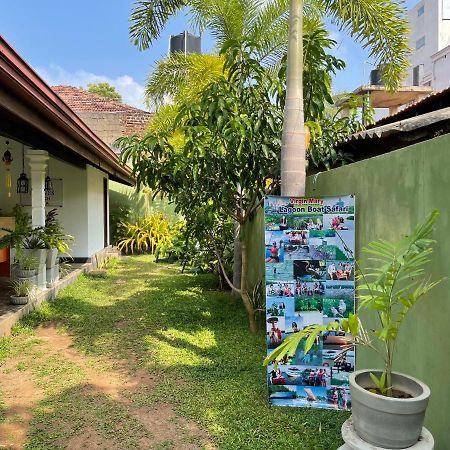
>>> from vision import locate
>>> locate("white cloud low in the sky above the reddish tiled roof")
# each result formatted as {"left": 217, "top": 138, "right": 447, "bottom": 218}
{"left": 37, "top": 64, "right": 147, "bottom": 109}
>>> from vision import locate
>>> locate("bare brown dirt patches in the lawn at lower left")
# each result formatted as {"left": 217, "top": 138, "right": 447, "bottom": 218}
{"left": 0, "top": 324, "right": 215, "bottom": 450}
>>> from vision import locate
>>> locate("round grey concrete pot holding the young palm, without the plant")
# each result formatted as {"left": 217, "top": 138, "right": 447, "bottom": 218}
{"left": 349, "top": 370, "right": 430, "bottom": 449}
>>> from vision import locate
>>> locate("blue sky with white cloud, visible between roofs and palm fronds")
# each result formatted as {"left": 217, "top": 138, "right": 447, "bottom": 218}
{"left": 0, "top": 0, "right": 418, "bottom": 109}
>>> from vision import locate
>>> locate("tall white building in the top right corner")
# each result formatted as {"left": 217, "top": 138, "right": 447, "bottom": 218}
{"left": 405, "top": 0, "right": 450, "bottom": 90}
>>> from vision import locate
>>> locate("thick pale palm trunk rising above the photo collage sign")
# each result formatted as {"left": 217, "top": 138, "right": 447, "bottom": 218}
{"left": 281, "top": 0, "right": 306, "bottom": 197}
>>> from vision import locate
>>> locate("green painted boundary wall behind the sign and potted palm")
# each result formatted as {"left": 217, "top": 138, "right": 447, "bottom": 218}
{"left": 249, "top": 135, "right": 450, "bottom": 450}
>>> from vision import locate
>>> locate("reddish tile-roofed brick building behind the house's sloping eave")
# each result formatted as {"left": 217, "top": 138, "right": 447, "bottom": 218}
{"left": 52, "top": 86, "right": 153, "bottom": 150}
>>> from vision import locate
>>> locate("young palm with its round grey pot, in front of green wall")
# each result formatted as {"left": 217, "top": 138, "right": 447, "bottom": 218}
{"left": 265, "top": 211, "right": 442, "bottom": 449}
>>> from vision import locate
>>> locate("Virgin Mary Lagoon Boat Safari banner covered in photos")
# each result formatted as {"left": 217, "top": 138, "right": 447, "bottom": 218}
{"left": 264, "top": 195, "right": 355, "bottom": 410}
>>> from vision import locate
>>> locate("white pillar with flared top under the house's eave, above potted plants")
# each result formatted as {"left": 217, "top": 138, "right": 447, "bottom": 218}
{"left": 26, "top": 150, "right": 48, "bottom": 227}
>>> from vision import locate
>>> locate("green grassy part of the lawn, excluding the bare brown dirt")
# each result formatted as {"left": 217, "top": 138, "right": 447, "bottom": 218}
{"left": 13, "top": 256, "right": 348, "bottom": 450}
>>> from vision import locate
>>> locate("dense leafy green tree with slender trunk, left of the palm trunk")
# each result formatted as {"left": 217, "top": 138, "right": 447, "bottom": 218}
{"left": 118, "top": 42, "right": 283, "bottom": 331}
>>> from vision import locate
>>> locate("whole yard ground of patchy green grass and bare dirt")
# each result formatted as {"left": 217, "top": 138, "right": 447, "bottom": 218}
{"left": 0, "top": 256, "right": 348, "bottom": 450}
